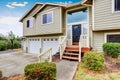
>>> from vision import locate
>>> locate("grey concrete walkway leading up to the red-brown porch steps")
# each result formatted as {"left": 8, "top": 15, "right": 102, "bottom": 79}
{"left": 56, "top": 60, "right": 78, "bottom": 80}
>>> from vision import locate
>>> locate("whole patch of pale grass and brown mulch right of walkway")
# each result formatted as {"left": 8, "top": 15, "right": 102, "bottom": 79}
{"left": 74, "top": 55, "right": 120, "bottom": 80}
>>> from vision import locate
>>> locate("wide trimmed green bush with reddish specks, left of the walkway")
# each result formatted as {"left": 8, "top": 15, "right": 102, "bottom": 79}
{"left": 24, "top": 62, "right": 56, "bottom": 80}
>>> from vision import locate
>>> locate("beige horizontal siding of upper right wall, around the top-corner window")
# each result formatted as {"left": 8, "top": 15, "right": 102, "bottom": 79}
{"left": 94, "top": 0, "right": 120, "bottom": 30}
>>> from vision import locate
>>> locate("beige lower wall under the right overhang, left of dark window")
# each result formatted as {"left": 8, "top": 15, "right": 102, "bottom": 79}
{"left": 93, "top": 30, "right": 120, "bottom": 52}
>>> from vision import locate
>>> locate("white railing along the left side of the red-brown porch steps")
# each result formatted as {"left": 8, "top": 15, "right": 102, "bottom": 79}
{"left": 59, "top": 36, "right": 67, "bottom": 59}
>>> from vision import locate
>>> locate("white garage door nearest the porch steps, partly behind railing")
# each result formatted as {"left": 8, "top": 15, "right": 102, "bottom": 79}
{"left": 43, "top": 38, "right": 59, "bottom": 54}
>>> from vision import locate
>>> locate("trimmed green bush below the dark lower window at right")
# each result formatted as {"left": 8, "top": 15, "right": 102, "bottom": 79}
{"left": 103, "top": 43, "right": 120, "bottom": 58}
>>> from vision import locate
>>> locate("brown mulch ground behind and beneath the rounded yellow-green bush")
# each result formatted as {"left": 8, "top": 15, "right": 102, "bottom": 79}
{"left": 84, "top": 55, "right": 120, "bottom": 74}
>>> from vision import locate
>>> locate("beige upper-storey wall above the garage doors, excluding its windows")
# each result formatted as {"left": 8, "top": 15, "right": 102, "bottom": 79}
{"left": 23, "top": 6, "right": 62, "bottom": 36}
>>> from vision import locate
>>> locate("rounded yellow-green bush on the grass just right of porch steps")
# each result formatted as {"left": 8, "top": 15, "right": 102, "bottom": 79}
{"left": 83, "top": 52, "right": 104, "bottom": 70}
